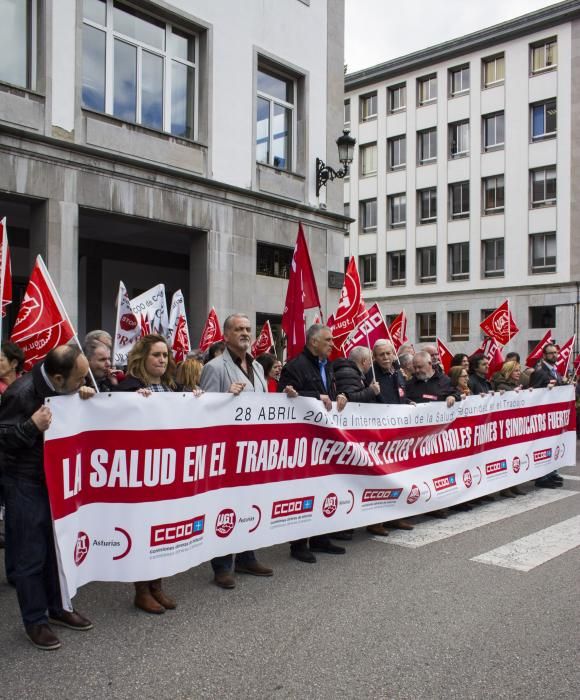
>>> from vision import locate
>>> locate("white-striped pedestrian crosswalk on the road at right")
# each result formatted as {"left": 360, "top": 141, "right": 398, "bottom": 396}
{"left": 372, "top": 484, "right": 580, "bottom": 572}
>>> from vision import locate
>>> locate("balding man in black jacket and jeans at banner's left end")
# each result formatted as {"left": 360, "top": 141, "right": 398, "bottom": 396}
{"left": 0, "top": 345, "right": 95, "bottom": 650}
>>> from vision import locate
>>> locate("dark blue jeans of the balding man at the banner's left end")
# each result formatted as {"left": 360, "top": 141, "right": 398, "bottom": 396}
{"left": 4, "top": 476, "right": 63, "bottom": 626}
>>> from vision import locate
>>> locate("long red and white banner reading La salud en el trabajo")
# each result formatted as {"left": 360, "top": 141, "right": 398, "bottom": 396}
{"left": 45, "top": 386, "right": 576, "bottom": 603}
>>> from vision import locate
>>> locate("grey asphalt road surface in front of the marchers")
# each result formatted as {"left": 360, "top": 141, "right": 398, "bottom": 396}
{"left": 0, "top": 465, "right": 580, "bottom": 700}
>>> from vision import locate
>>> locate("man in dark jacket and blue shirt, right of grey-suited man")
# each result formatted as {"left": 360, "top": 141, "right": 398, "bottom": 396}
{"left": 278, "top": 323, "right": 348, "bottom": 564}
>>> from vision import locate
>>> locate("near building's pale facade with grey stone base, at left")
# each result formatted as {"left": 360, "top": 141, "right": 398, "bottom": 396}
{"left": 0, "top": 0, "right": 346, "bottom": 343}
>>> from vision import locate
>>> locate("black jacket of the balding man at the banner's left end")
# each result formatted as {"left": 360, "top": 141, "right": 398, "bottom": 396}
{"left": 0, "top": 364, "right": 57, "bottom": 483}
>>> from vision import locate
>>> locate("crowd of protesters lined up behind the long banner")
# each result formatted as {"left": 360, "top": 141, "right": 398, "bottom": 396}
{"left": 0, "top": 314, "right": 567, "bottom": 650}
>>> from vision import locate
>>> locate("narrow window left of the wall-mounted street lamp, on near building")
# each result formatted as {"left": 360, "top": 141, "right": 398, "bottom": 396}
{"left": 256, "top": 64, "right": 296, "bottom": 170}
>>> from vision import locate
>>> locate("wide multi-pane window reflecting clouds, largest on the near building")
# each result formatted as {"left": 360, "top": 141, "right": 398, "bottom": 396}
{"left": 82, "top": 0, "right": 198, "bottom": 139}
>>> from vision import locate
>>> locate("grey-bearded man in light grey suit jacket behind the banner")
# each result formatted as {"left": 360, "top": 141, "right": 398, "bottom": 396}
{"left": 199, "top": 313, "right": 274, "bottom": 588}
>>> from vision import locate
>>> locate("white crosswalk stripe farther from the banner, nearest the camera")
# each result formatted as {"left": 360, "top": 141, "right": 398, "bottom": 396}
{"left": 471, "top": 515, "right": 580, "bottom": 571}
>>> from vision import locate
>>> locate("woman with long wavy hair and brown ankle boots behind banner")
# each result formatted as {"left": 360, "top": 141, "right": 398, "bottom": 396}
{"left": 117, "top": 333, "right": 177, "bottom": 615}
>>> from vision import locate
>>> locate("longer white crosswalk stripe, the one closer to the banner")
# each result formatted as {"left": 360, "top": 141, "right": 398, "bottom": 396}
{"left": 372, "top": 488, "right": 580, "bottom": 549}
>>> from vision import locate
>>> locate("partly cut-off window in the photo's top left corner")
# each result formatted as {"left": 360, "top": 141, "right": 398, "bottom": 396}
{"left": 0, "top": 0, "right": 37, "bottom": 89}
